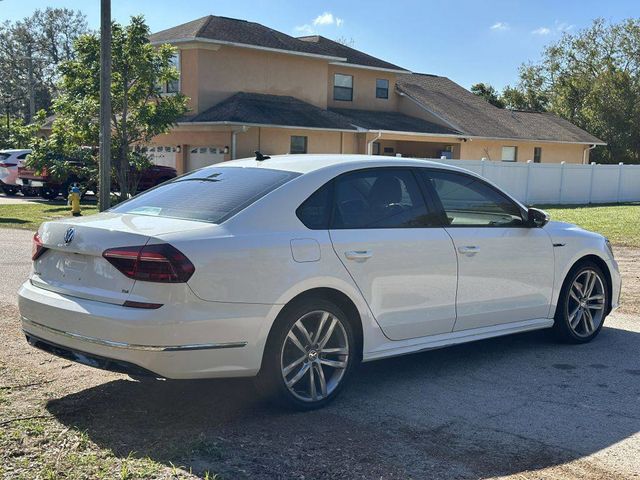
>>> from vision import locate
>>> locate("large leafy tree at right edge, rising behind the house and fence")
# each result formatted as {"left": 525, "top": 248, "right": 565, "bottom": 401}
{"left": 517, "top": 19, "right": 640, "bottom": 163}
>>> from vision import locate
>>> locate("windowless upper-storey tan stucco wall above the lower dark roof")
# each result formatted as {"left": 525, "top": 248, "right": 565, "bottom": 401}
{"left": 181, "top": 45, "right": 327, "bottom": 113}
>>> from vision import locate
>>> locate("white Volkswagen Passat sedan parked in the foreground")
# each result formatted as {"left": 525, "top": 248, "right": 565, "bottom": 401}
{"left": 19, "top": 155, "right": 620, "bottom": 409}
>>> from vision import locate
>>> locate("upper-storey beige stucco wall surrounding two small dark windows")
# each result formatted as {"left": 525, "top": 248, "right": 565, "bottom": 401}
{"left": 326, "top": 65, "right": 398, "bottom": 110}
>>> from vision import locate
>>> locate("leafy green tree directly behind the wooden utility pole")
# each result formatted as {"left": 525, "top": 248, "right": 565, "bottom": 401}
{"left": 30, "top": 16, "right": 187, "bottom": 198}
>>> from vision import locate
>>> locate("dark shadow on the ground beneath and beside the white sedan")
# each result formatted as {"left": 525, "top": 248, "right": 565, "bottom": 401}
{"left": 47, "top": 327, "right": 640, "bottom": 478}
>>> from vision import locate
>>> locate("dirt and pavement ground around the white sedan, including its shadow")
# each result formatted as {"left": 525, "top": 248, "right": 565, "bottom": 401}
{"left": 0, "top": 231, "right": 640, "bottom": 479}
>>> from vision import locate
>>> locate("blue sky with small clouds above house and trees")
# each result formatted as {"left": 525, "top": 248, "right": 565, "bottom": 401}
{"left": 0, "top": 0, "right": 640, "bottom": 88}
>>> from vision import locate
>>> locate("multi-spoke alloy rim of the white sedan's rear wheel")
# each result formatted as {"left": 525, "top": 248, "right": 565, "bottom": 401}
{"left": 280, "top": 310, "right": 349, "bottom": 402}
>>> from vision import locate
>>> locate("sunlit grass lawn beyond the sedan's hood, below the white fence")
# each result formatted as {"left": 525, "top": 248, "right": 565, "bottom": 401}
{"left": 540, "top": 203, "right": 640, "bottom": 247}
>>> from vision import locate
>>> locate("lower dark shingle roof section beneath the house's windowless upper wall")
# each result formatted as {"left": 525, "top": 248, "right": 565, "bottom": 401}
{"left": 186, "top": 92, "right": 355, "bottom": 130}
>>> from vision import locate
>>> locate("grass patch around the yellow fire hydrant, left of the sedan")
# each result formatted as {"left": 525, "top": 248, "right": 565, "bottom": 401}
{"left": 0, "top": 200, "right": 98, "bottom": 231}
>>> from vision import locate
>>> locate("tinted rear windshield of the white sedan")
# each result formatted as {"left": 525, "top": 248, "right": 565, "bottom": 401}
{"left": 110, "top": 167, "right": 300, "bottom": 223}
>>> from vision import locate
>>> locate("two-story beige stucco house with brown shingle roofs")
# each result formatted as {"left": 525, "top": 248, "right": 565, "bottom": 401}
{"left": 151, "top": 16, "right": 603, "bottom": 171}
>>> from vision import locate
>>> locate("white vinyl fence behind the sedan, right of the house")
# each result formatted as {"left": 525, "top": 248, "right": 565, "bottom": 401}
{"left": 434, "top": 159, "right": 640, "bottom": 205}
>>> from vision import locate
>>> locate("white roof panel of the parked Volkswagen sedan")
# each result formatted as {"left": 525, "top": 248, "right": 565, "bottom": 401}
{"left": 215, "top": 154, "right": 467, "bottom": 174}
